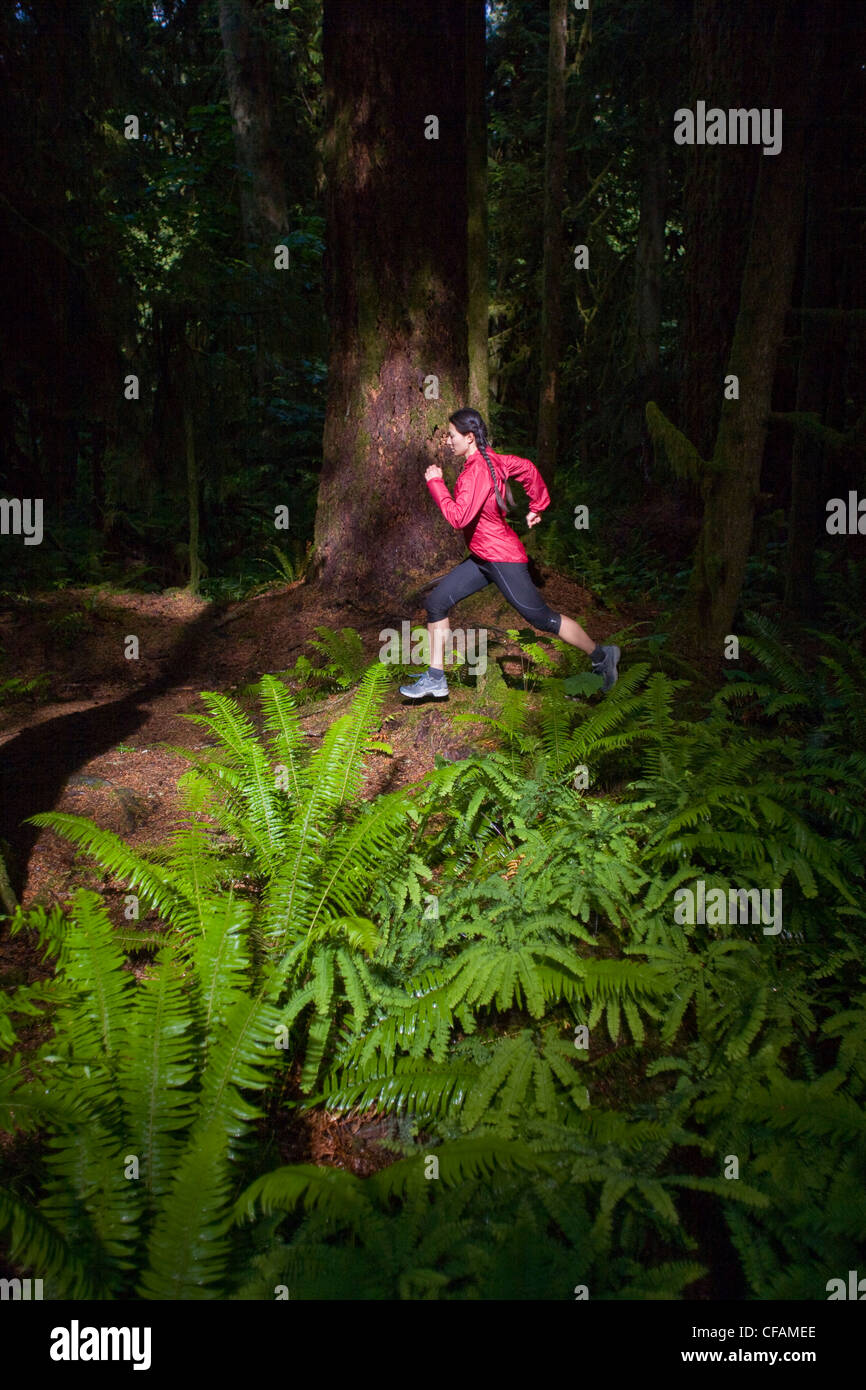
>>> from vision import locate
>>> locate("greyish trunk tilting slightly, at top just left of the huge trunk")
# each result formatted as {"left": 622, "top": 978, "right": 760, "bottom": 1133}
{"left": 220, "top": 0, "right": 288, "bottom": 259}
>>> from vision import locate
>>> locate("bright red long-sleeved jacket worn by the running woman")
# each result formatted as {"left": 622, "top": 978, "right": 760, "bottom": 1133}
{"left": 427, "top": 449, "right": 550, "bottom": 564}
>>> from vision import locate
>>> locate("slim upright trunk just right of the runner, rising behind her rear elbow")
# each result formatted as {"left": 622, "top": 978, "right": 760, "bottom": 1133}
{"left": 535, "top": 0, "right": 569, "bottom": 485}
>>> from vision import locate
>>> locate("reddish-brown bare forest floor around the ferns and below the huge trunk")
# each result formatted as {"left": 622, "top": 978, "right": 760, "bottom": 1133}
{"left": 0, "top": 570, "right": 653, "bottom": 1175}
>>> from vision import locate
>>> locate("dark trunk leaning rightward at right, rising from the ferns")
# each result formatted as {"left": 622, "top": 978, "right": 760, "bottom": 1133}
{"left": 676, "top": 0, "right": 824, "bottom": 662}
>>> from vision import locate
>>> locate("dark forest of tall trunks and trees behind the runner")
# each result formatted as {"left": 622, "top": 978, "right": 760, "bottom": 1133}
{"left": 0, "top": 0, "right": 866, "bottom": 648}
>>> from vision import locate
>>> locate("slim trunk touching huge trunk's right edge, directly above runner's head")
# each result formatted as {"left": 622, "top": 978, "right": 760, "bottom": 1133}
{"left": 466, "top": 0, "right": 489, "bottom": 420}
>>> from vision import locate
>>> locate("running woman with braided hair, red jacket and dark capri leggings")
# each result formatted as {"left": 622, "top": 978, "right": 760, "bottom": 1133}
{"left": 400, "top": 409, "right": 620, "bottom": 699}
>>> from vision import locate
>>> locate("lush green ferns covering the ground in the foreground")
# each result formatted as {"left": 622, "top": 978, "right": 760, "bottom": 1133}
{"left": 0, "top": 621, "right": 866, "bottom": 1300}
